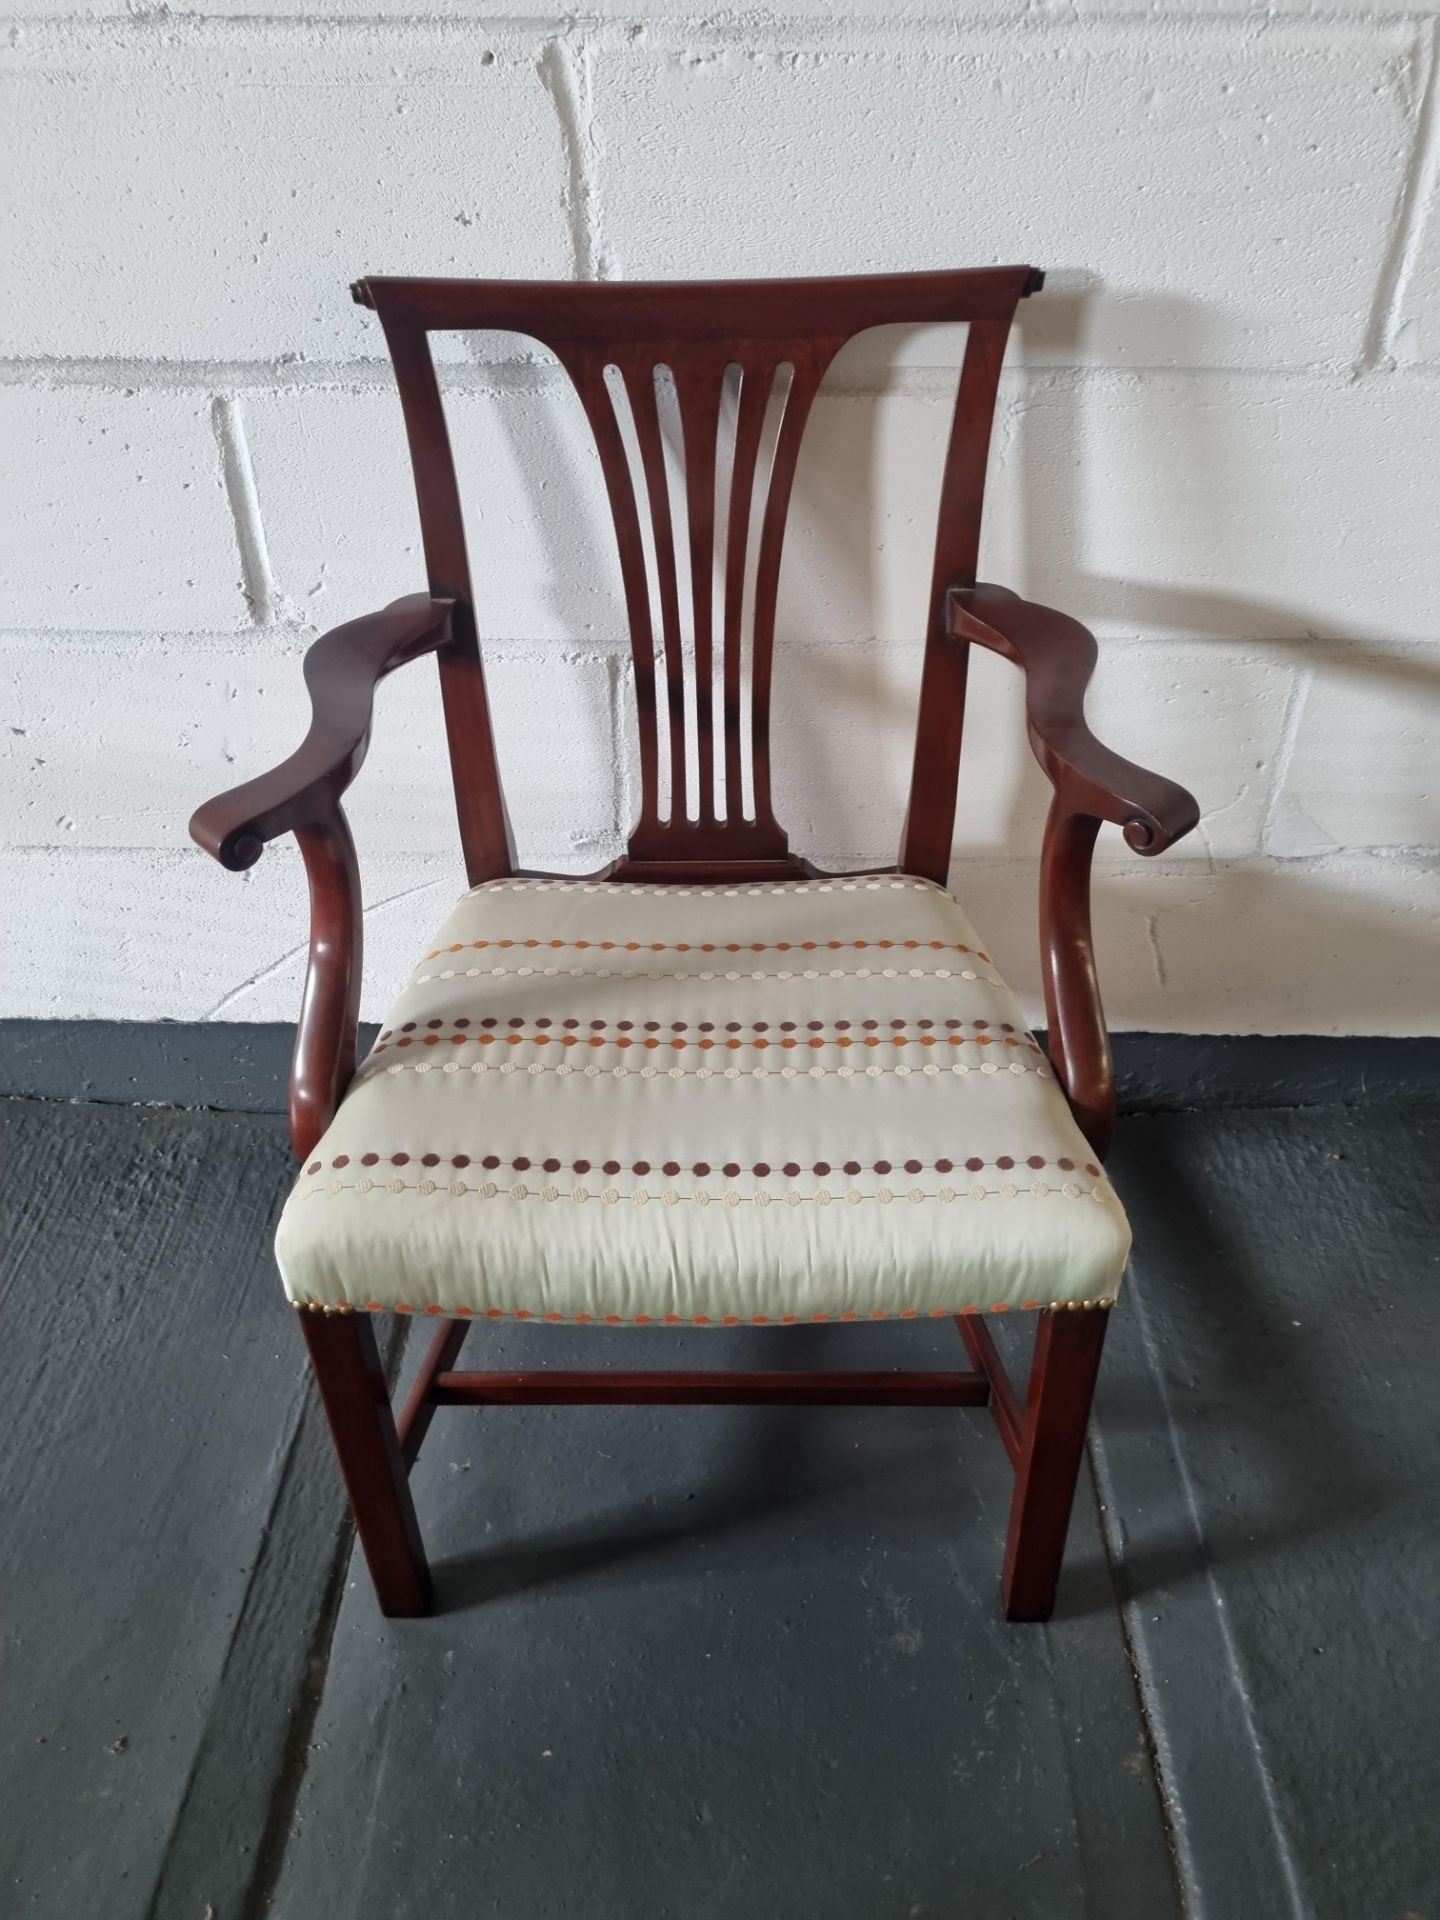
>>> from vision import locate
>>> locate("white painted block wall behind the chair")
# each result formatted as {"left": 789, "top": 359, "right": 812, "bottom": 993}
{"left": 0, "top": 0, "right": 1440, "bottom": 1033}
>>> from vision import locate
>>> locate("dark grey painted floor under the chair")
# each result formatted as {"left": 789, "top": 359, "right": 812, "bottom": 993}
{"left": 0, "top": 1100, "right": 1440, "bottom": 1920}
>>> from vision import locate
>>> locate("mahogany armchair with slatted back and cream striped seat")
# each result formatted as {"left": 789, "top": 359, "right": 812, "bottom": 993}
{"left": 190, "top": 267, "right": 1198, "bottom": 1620}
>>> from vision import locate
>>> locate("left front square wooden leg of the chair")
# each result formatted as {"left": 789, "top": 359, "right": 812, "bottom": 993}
{"left": 300, "top": 1313, "right": 430, "bottom": 1617}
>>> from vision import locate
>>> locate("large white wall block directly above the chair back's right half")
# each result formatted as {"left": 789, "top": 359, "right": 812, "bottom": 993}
{"left": 595, "top": 23, "right": 1415, "bottom": 367}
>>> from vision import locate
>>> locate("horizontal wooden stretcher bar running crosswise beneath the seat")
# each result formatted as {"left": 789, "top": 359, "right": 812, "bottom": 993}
{"left": 434, "top": 1367, "right": 991, "bottom": 1407}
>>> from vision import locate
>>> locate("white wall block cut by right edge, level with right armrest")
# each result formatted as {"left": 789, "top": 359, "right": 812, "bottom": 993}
{"left": 1267, "top": 645, "right": 1440, "bottom": 854}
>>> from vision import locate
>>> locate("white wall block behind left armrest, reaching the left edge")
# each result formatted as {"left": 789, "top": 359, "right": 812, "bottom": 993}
{"left": 0, "top": 636, "right": 616, "bottom": 860}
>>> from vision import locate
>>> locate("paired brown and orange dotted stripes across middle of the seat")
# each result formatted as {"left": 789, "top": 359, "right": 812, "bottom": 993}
{"left": 372, "top": 1014, "right": 1041, "bottom": 1056}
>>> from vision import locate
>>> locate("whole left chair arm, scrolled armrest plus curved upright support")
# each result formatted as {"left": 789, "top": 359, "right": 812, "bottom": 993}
{"left": 190, "top": 593, "right": 451, "bottom": 1160}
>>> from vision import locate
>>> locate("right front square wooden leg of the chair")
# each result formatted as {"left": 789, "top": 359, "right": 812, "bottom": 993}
{"left": 1002, "top": 1308, "right": 1110, "bottom": 1620}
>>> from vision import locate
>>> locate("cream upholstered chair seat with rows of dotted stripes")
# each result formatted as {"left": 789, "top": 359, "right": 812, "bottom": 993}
{"left": 278, "top": 876, "right": 1129, "bottom": 1325}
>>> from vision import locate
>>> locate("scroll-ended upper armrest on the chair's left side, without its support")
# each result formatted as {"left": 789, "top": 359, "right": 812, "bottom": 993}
{"left": 190, "top": 593, "right": 453, "bottom": 874}
